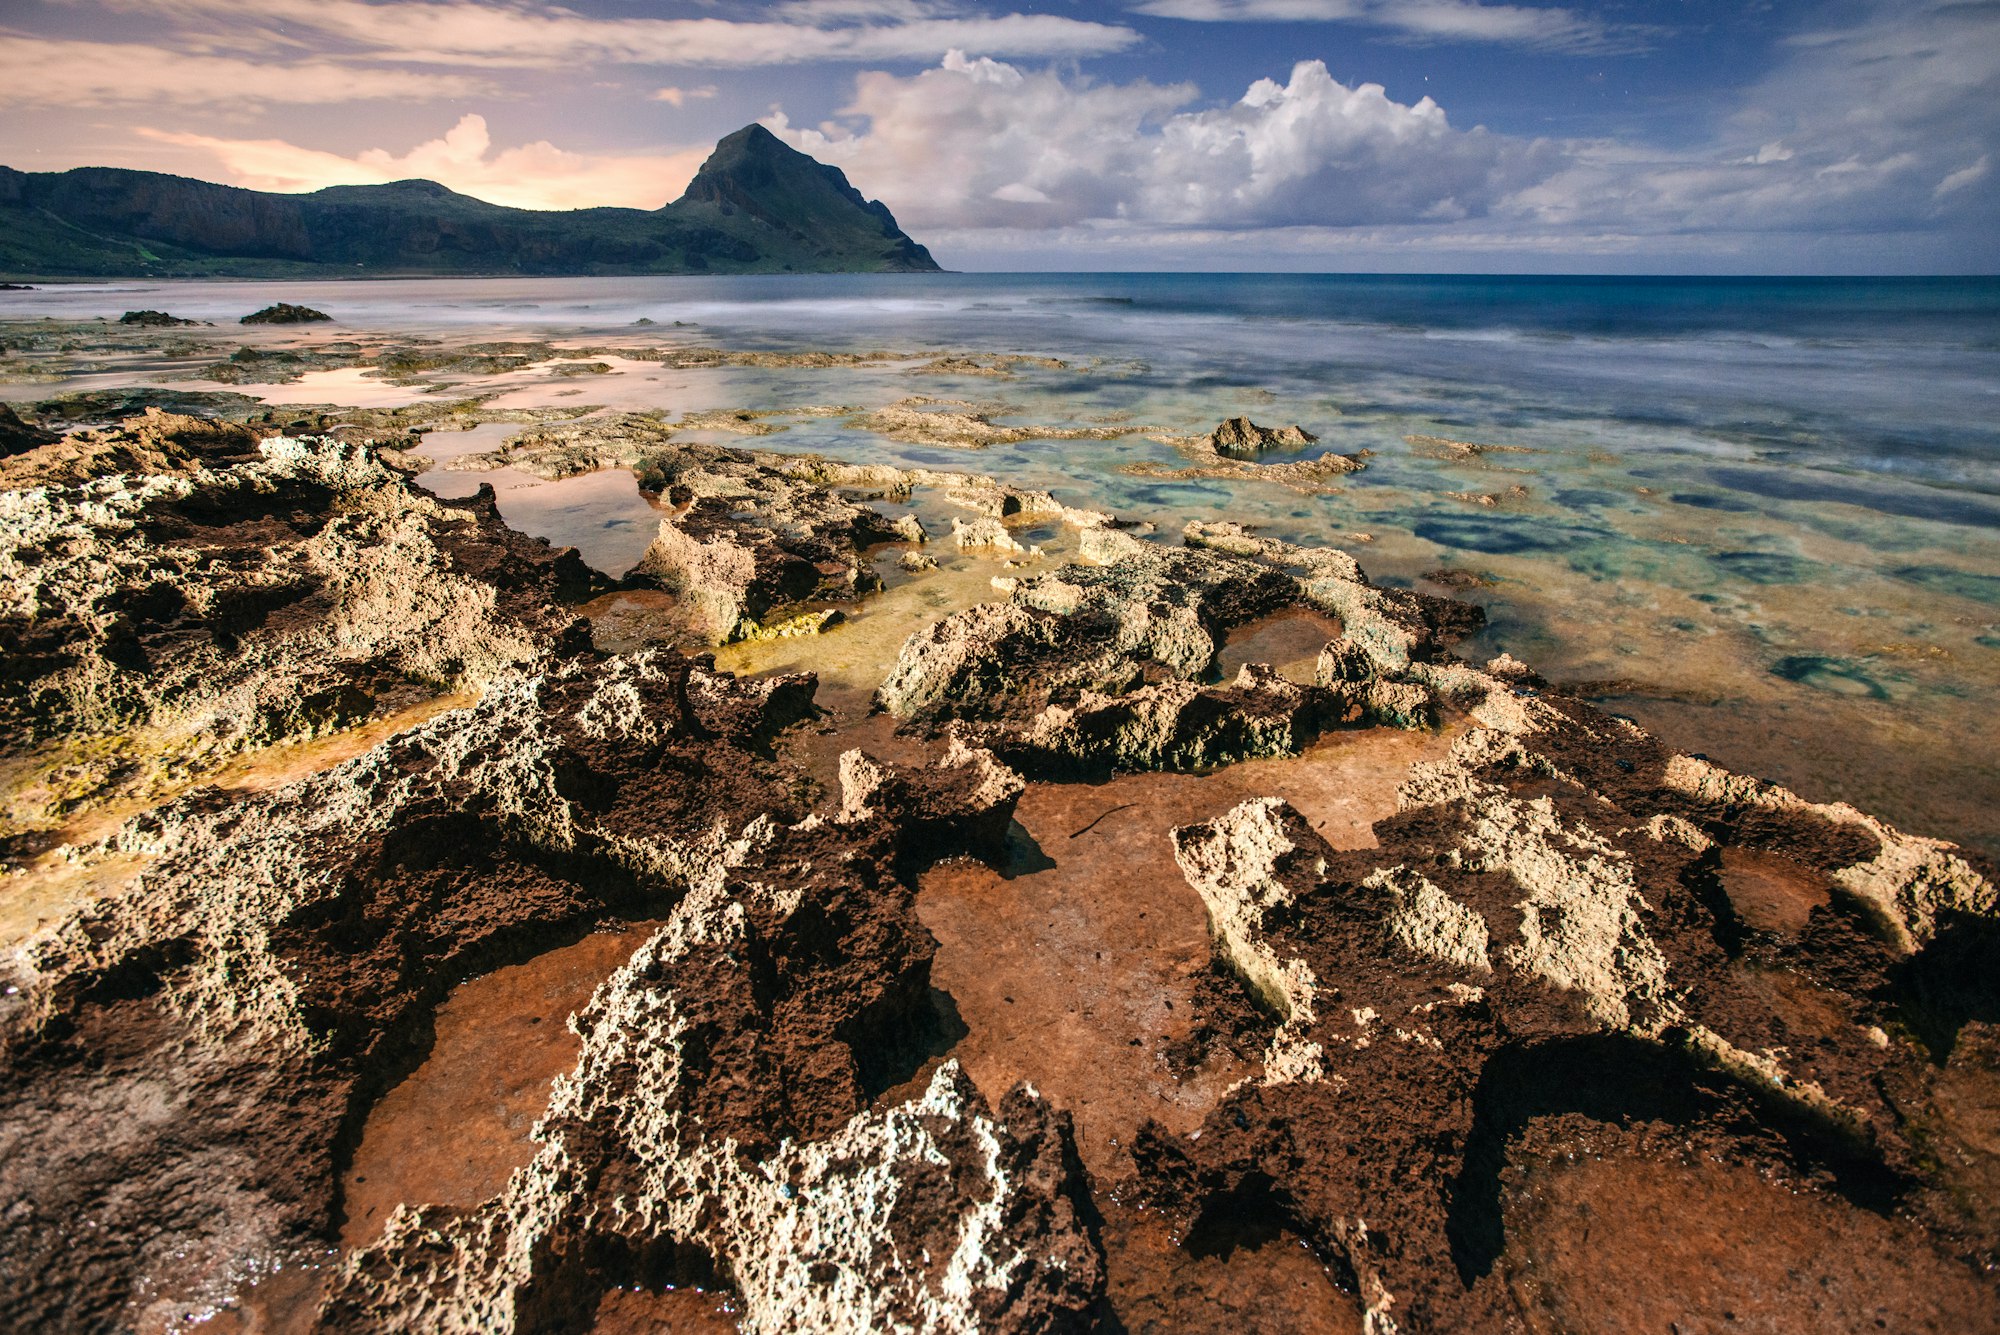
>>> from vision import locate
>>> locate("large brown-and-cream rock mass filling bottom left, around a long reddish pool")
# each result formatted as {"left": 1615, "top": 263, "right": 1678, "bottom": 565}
{"left": 0, "top": 654, "right": 1102, "bottom": 1329}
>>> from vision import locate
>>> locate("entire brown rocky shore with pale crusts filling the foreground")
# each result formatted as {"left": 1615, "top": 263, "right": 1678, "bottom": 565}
{"left": 0, "top": 414, "right": 2000, "bottom": 1335}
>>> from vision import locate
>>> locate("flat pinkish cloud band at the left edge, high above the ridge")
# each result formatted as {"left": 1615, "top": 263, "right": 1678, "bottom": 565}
{"left": 0, "top": 30, "right": 492, "bottom": 108}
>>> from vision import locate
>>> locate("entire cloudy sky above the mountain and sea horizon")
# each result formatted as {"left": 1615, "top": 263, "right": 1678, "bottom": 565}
{"left": 0, "top": 0, "right": 2000, "bottom": 274}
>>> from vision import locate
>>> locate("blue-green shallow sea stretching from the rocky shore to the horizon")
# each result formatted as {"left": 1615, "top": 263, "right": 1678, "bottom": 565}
{"left": 0, "top": 274, "right": 2000, "bottom": 855}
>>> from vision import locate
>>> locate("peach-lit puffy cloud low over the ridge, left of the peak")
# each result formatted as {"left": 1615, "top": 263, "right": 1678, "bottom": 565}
{"left": 140, "top": 116, "right": 710, "bottom": 208}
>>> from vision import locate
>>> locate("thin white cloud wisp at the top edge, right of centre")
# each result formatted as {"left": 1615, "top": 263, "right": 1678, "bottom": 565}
{"left": 1130, "top": 0, "right": 1652, "bottom": 54}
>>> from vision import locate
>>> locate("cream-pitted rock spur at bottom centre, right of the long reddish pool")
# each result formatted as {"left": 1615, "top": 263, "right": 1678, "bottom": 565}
{"left": 326, "top": 735, "right": 1102, "bottom": 1331}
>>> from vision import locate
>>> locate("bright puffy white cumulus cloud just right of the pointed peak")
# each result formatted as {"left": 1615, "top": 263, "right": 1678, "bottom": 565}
{"left": 766, "top": 52, "right": 1556, "bottom": 228}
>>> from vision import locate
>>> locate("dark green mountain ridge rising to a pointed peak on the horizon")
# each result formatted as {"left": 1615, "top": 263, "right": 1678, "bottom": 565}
{"left": 0, "top": 126, "right": 938, "bottom": 278}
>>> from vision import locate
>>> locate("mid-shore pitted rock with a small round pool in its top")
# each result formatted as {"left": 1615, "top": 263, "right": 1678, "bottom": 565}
{"left": 876, "top": 524, "right": 1476, "bottom": 773}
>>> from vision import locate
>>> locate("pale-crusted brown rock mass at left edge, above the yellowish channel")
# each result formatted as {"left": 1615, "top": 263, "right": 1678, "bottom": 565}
{"left": 0, "top": 414, "right": 592, "bottom": 837}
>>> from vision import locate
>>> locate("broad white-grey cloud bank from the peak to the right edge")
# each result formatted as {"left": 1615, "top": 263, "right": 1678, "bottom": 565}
{"left": 766, "top": 0, "right": 2000, "bottom": 270}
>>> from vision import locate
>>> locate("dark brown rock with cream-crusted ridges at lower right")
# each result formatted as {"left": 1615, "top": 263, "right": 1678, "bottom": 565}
{"left": 1138, "top": 656, "right": 2000, "bottom": 1331}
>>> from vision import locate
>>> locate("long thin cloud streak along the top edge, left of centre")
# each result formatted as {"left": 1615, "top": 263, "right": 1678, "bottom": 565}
{"left": 90, "top": 0, "right": 1140, "bottom": 70}
